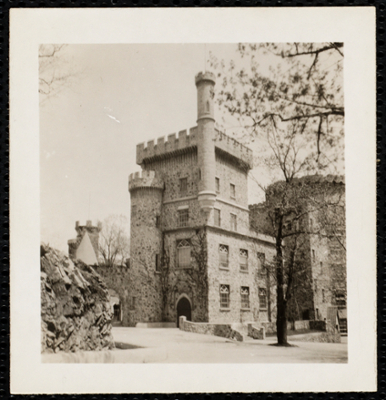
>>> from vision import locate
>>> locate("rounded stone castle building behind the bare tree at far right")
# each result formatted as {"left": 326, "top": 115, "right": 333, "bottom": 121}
{"left": 250, "top": 175, "right": 347, "bottom": 331}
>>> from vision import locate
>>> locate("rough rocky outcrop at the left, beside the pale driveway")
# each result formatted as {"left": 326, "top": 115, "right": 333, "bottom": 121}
{"left": 40, "top": 245, "right": 114, "bottom": 352}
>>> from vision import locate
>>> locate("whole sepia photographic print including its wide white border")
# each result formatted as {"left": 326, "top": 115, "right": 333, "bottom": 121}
{"left": 10, "top": 8, "right": 376, "bottom": 394}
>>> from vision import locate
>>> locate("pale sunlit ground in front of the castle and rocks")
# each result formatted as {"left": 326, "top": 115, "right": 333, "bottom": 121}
{"left": 43, "top": 327, "right": 347, "bottom": 363}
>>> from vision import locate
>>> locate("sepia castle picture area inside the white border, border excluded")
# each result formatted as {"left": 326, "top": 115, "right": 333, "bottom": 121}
{"left": 39, "top": 42, "right": 348, "bottom": 363}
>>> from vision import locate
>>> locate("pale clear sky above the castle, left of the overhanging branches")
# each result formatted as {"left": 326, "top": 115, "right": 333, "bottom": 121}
{"left": 39, "top": 44, "right": 346, "bottom": 252}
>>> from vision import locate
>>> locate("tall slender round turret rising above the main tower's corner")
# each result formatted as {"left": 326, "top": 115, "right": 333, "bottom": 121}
{"left": 196, "top": 72, "right": 216, "bottom": 213}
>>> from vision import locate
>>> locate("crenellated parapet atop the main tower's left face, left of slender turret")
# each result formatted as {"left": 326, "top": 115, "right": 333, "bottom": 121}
{"left": 137, "top": 127, "right": 197, "bottom": 165}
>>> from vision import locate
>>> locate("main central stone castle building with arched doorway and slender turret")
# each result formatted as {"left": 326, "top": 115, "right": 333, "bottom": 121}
{"left": 127, "top": 72, "right": 275, "bottom": 325}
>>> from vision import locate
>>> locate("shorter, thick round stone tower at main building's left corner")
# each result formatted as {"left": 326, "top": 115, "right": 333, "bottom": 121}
{"left": 129, "top": 171, "right": 164, "bottom": 322}
